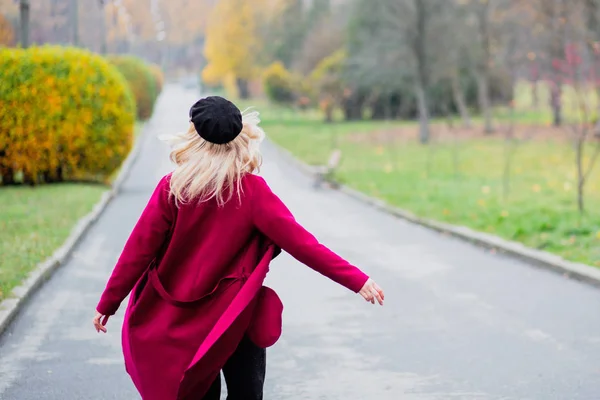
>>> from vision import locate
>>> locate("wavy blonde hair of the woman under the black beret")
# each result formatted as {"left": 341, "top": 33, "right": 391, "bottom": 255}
{"left": 163, "top": 111, "right": 265, "bottom": 206}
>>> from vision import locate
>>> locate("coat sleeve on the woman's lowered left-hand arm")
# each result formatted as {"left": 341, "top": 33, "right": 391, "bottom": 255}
{"left": 96, "top": 177, "right": 175, "bottom": 315}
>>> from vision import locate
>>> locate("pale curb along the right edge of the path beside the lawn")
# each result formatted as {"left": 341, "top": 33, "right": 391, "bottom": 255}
{"left": 269, "top": 141, "right": 600, "bottom": 287}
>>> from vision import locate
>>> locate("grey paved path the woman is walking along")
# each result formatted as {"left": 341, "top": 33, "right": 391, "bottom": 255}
{"left": 0, "top": 87, "right": 600, "bottom": 400}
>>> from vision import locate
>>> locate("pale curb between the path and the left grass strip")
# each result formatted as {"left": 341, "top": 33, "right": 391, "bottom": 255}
{"left": 0, "top": 127, "right": 145, "bottom": 337}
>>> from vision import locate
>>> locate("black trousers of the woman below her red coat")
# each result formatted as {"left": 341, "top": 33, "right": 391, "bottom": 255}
{"left": 203, "top": 338, "right": 267, "bottom": 400}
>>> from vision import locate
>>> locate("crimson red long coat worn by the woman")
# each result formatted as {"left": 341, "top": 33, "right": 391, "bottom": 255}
{"left": 97, "top": 175, "right": 368, "bottom": 400}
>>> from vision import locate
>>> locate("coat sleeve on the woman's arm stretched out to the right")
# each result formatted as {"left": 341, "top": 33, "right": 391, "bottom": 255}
{"left": 252, "top": 176, "right": 369, "bottom": 292}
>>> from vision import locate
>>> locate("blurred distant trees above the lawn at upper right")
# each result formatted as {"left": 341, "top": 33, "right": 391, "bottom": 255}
{"left": 191, "top": 0, "right": 600, "bottom": 143}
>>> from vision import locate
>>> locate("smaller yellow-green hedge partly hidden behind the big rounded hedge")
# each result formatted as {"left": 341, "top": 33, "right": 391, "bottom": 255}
{"left": 108, "top": 56, "right": 158, "bottom": 121}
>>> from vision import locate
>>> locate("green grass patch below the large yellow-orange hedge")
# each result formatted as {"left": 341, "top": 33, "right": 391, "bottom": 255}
{"left": 0, "top": 184, "right": 107, "bottom": 300}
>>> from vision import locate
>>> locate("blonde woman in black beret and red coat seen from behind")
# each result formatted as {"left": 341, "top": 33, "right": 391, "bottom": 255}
{"left": 93, "top": 96, "right": 384, "bottom": 400}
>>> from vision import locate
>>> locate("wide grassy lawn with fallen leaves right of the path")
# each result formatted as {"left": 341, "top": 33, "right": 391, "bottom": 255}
{"left": 243, "top": 99, "right": 600, "bottom": 266}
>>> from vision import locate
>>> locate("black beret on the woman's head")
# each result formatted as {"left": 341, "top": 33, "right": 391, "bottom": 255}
{"left": 190, "top": 96, "right": 243, "bottom": 144}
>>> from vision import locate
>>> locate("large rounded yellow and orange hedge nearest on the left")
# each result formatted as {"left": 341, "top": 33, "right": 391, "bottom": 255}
{"left": 0, "top": 46, "right": 135, "bottom": 184}
